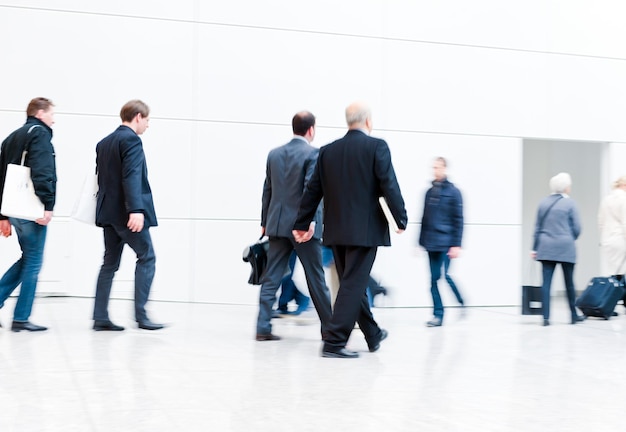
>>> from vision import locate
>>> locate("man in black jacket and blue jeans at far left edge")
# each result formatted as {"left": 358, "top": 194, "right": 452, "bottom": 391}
{"left": 0, "top": 97, "right": 57, "bottom": 332}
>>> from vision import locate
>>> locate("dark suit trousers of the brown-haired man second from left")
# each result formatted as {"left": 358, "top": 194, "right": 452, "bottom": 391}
{"left": 93, "top": 226, "right": 156, "bottom": 322}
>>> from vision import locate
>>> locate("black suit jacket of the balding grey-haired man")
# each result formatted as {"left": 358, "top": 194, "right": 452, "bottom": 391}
{"left": 294, "top": 130, "right": 407, "bottom": 247}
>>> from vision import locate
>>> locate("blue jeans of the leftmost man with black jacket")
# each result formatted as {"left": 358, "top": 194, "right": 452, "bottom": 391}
{"left": 0, "top": 218, "right": 47, "bottom": 322}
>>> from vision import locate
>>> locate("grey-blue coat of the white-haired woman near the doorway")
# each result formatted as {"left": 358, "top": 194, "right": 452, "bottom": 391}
{"left": 533, "top": 194, "right": 581, "bottom": 263}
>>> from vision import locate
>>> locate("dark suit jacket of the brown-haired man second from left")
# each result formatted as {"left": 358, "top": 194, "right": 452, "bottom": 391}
{"left": 96, "top": 125, "right": 157, "bottom": 227}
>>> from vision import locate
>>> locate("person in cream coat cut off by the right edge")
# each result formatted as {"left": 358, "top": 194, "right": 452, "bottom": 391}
{"left": 598, "top": 176, "right": 626, "bottom": 277}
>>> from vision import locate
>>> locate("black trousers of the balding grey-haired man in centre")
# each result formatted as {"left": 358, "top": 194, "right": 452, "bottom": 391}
{"left": 324, "top": 245, "right": 380, "bottom": 349}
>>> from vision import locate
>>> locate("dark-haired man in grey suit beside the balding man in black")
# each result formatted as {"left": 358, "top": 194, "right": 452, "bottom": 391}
{"left": 256, "top": 111, "right": 332, "bottom": 341}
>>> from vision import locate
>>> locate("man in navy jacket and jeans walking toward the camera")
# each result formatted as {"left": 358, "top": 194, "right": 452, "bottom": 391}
{"left": 419, "top": 157, "right": 463, "bottom": 327}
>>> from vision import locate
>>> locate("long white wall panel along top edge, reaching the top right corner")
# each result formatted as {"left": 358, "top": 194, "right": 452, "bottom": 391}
{"left": 196, "top": 0, "right": 626, "bottom": 57}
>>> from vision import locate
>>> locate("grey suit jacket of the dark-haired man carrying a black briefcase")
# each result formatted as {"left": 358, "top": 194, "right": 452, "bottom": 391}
{"left": 261, "top": 138, "right": 322, "bottom": 239}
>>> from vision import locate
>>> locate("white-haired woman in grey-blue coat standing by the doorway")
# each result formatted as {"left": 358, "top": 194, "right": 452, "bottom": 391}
{"left": 531, "top": 173, "right": 585, "bottom": 326}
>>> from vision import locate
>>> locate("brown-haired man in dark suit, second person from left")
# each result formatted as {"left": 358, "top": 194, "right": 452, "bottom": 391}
{"left": 93, "top": 100, "right": 163, "bottom": 331}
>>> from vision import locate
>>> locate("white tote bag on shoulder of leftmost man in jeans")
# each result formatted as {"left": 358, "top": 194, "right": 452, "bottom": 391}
{"left": 0, "top": 152, "right": 45, "bottom": 221}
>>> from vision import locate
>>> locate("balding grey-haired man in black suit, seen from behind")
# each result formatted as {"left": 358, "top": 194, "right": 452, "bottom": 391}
{"left": 293, "top": 103, "right": 407, "bottom": 358}
